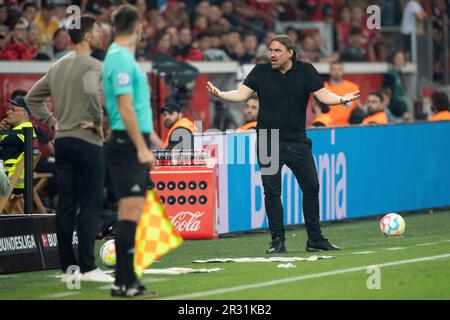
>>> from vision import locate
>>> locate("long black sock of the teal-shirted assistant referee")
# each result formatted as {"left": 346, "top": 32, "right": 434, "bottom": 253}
{"left": 115, "top": 220, "right": 137, "bottom": 287}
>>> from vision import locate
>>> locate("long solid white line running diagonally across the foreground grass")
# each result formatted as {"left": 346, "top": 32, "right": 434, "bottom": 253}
{"left": 159, "top": 253, "right": 450, "bottom": 300}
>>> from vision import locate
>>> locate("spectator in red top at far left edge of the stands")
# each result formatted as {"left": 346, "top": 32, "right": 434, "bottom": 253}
{"left": 0, "top": 20, "right": 37, "bottom": 60}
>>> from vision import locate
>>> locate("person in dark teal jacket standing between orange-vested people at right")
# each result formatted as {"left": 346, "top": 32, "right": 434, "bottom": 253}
{"left": 383, "top": 51, "right": 411, "bottom": 121}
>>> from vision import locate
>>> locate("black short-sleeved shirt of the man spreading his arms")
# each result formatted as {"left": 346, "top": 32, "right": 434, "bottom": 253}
{"left": 244, "top": 61, "right": 323, "bottom": 142}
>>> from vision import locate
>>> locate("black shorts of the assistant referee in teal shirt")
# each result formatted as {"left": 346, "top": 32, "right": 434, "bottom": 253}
{"left": 106, "top": 131, "right": 153, "bottom": 199}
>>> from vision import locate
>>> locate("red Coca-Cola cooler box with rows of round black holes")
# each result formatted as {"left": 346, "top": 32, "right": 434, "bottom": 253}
{"left": 151, "top": 166, "right": 217, "bottom": 240}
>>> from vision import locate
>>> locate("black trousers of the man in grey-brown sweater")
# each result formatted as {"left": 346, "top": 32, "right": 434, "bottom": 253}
{"left": 55, "top": 138, "right": 105, "bottom": 273}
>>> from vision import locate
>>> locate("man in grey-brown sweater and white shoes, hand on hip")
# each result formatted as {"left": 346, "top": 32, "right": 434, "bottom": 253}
{"left": 25, "top": 16, "right": 114, "bottom": 282}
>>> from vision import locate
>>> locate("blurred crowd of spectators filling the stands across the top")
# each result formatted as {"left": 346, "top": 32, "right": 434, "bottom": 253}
{"left": 0, "top": 0, "right": 450, "bottom": 64}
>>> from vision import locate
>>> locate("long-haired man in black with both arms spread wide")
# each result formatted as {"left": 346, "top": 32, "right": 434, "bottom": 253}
{"left": 206, "top": 35, "right": 359, "bottom": 254}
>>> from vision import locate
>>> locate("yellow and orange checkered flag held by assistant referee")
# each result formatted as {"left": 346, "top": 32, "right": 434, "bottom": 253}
{"left": 134, "top": 190, "right": 183, "bottom": 277}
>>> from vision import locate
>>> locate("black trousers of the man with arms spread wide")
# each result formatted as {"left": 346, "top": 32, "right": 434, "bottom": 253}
{"left": 258, "top": 138, "right": 323, "bottom": 241}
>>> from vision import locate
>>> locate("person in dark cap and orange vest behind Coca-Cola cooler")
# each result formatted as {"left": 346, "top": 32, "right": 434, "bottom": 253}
{"left": 161, "top": 101, "right": 197, "bottom": 150}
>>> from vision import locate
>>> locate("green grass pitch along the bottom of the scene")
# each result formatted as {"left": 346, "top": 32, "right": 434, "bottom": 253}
{"left": 0, "top": 211, "right": 450, "bottom": 299}
